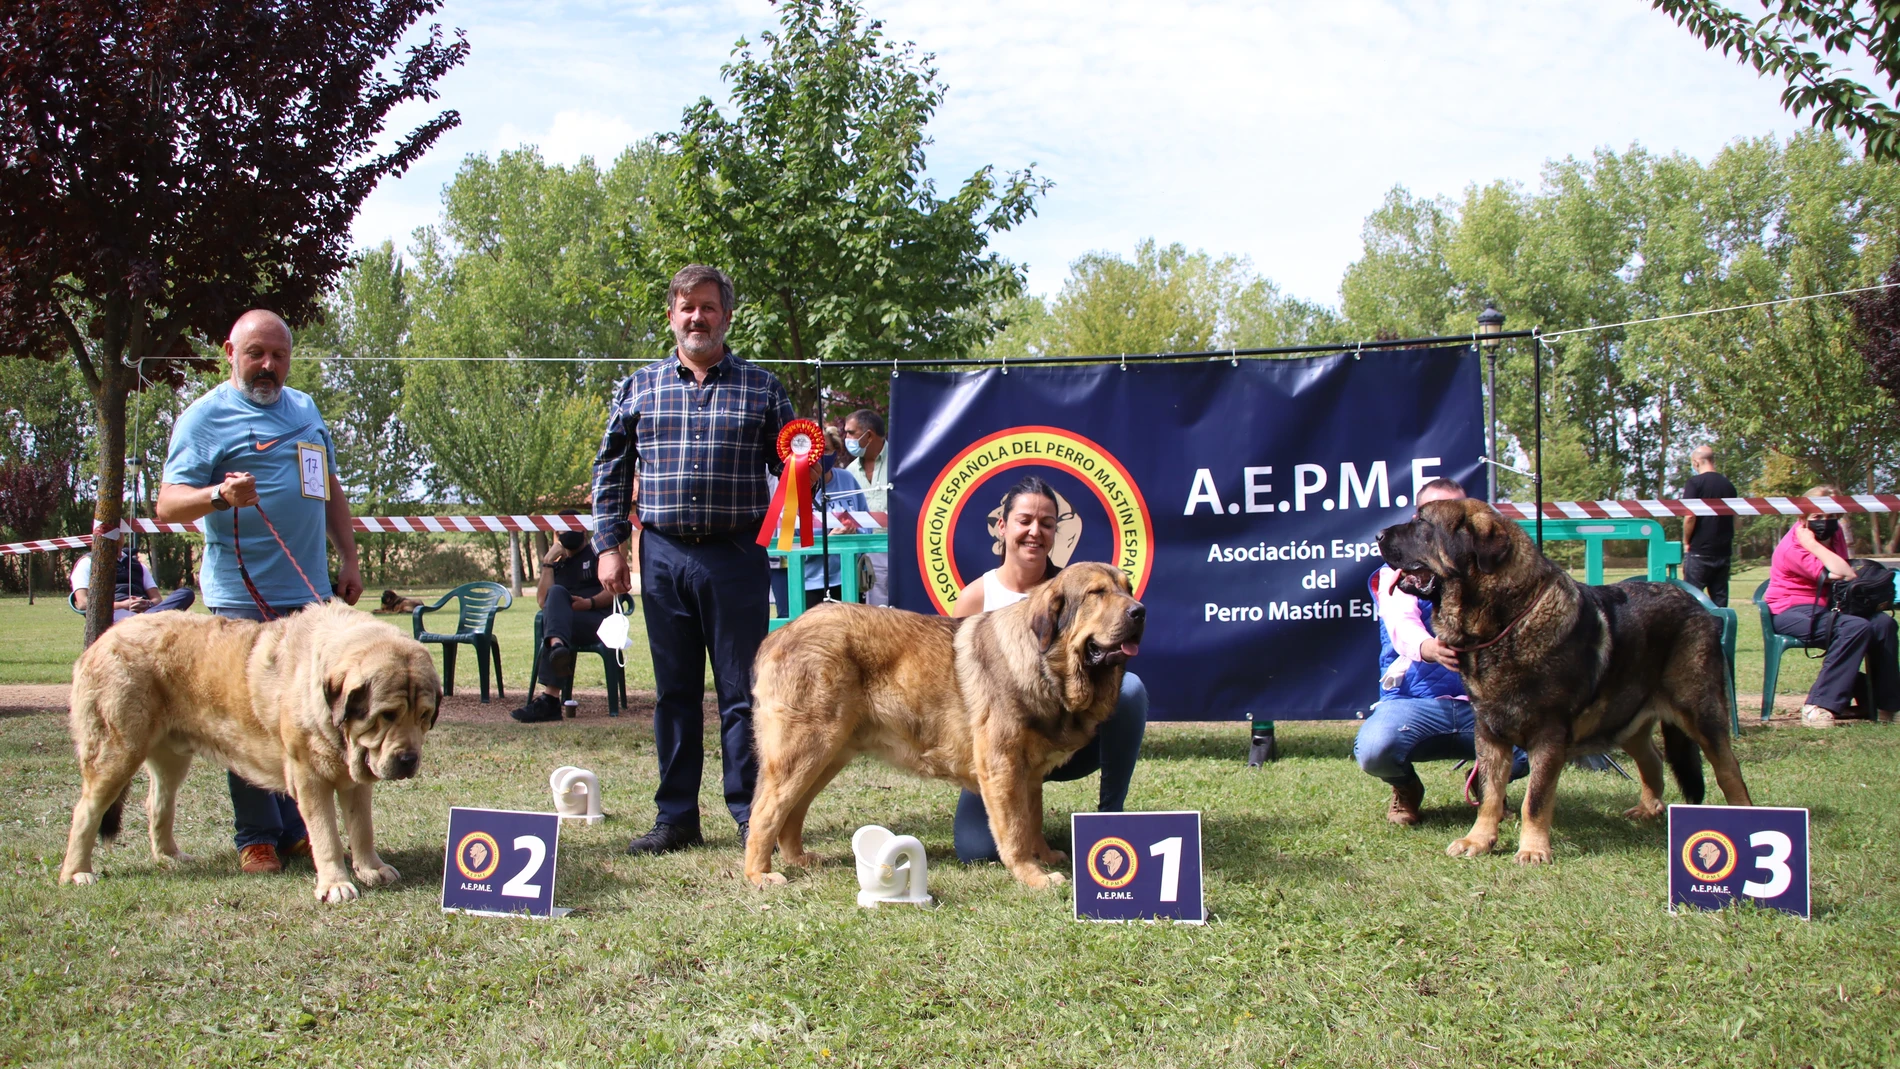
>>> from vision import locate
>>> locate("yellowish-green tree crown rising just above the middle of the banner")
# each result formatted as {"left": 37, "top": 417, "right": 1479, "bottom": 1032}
{"left": 986, "top": 237, "right": 1338, "bottom": 357}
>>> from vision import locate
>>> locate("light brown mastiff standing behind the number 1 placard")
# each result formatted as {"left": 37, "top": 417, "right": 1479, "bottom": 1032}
{"left": 745, "top": 564, "right": 1148, "bottom": 887}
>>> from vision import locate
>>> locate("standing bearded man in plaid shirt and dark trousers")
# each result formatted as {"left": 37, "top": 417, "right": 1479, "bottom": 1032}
{"left": 593, "top": 264, "right": 792, "bottom": 854}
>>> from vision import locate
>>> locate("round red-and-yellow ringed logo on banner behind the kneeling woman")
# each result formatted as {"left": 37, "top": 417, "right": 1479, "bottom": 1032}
{"left": 918, "top": 425, "right": 1155, "bottom": 615}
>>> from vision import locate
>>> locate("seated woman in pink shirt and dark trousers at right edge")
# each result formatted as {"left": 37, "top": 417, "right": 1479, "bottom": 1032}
{"left": 1763, "top": 486, "right": 1900, "bottom": 727}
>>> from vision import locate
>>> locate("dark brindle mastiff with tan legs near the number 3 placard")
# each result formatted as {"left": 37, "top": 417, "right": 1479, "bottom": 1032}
{"left": 1379, "top": 499, "right": 1752, "bottom": 864}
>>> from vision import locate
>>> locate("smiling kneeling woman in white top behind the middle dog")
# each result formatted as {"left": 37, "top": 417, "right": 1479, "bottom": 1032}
{"left": 952, "top": 475, "right": 1148, "bottom": 862}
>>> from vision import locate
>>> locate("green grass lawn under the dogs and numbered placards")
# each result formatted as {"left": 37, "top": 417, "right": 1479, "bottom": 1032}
{"left": 0, "top": 565, "right": 1900, "bottom": 1067}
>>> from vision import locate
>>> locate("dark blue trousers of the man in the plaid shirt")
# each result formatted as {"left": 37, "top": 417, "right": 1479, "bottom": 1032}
{"left": 640, "top": 528, "right": 771, "bottom": 828}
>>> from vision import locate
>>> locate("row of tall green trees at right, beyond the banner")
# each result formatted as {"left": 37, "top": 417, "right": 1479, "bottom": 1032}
{"left": 1341, "top": 133, "right": 1900, "bottom": 497}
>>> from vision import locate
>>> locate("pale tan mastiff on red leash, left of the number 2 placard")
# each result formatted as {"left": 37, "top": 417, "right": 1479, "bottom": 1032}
{"left": 59, "top": 602, "right": 441, "bottom": 902}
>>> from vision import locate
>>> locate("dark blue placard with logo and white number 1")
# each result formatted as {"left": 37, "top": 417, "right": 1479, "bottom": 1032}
{"left": 1070, "top": 813, "right": 1207, "bottom": 925}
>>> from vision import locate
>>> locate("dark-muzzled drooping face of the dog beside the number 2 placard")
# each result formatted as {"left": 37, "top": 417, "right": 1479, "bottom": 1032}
{"left": 323, "top": 640, "right": 443, "bottom": 782}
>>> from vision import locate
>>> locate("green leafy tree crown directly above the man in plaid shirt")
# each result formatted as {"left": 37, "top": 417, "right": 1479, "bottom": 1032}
{"left": 638, "top": 0, "right": 1049, "bottom": 412}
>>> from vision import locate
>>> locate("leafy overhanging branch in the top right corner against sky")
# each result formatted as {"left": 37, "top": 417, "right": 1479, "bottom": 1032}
{"left": 1651, "top": 0, "right": 1900, "bottom": 159}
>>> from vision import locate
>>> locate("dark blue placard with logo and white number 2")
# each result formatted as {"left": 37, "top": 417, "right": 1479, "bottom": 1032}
{"left": 443, "top": 805, "right": 566, "bottom": 917}
